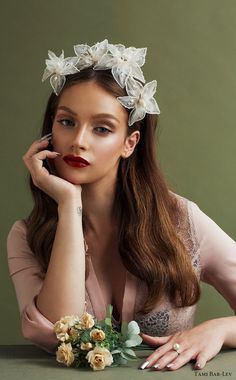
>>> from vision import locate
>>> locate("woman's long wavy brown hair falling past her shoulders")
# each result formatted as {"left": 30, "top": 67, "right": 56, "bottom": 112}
{"left": 26, "top": 68, "right": 200, "bottom": 313}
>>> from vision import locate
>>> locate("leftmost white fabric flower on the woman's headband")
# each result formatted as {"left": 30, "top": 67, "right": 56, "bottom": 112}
{"left": 42, "top": 50, "right": 79, "bottom": 95}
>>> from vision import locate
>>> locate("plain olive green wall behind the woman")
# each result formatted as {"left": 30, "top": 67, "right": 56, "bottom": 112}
{"left": 0, "top": 0, "right": 236, "bottom": 344}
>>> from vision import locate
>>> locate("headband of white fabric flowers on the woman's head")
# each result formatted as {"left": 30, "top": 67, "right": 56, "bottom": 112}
{"left": 42, "top": 40, "right": 160, "bottom": 126}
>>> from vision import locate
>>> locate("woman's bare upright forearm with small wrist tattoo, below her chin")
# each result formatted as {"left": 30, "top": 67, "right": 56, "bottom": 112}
{"left": 37, "top": 200, "right": 85, "bottom": 323}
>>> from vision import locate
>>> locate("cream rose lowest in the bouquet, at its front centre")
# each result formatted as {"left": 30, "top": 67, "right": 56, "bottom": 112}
{"left": 86, "top": 347, "right": 113, "bottom": 371}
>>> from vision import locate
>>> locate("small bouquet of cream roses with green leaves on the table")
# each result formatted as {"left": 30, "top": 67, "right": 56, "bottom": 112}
{"left": 54, "top": 305, "right": 142, "bottom": 371}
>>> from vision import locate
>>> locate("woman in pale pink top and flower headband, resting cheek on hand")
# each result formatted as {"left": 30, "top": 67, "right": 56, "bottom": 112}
{"left": 8, "top": 40, "right": 236, "bottom": 370}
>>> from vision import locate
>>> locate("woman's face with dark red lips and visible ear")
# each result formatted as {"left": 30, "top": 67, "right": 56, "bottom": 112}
{"left": 52, "top": 81, "right": 139, "bottom": 184}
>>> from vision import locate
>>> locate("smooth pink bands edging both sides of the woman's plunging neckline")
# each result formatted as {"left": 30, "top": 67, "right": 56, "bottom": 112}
{"left": 86, "top": 255, "right": 137, "bottom": 324}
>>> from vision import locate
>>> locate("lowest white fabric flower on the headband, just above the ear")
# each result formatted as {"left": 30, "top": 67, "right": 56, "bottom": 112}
{"left": 117, "top": 78, "right": 160, "bottom": 126}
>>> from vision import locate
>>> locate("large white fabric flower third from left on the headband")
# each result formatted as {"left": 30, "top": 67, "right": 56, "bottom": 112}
{"left": 94, "top": 44, "right": 147, "bottom": 88}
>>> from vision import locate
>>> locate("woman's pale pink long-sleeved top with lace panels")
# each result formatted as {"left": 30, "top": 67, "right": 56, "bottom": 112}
{"left": 7, "top": 196, "right": 236, "bottom": 353}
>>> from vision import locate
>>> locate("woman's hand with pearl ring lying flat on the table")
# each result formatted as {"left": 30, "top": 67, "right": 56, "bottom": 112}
{"left": 140, "top": 318, "right": 228, "bottom": 370}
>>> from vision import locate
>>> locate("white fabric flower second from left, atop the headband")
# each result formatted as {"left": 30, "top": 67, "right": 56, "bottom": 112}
{"left": 74, "top": 40, "right": 108, "bottom": 70}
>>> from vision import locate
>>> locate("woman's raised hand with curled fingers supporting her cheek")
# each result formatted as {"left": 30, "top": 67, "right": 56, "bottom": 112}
{"left": 23, "top": 135, "right": 82, "bottom": 204}
